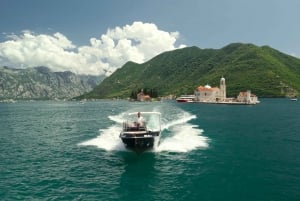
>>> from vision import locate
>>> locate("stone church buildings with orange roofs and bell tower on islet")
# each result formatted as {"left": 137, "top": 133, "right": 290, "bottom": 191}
{"left": 194, "top": 77, "right": 259, "bottom": 104}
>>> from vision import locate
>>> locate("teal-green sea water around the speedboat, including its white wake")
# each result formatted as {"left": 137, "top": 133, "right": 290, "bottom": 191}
{"left": 0, "top": 99, "right": 300, "bottom": 201}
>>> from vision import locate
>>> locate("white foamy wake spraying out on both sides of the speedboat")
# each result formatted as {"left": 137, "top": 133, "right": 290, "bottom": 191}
{"left": 79, "top": 103, "right": 209, "bottom": 152}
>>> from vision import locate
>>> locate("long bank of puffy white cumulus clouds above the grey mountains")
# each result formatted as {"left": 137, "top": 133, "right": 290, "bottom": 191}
{"left": 0, "top": 22, "right": 185, "bottom": 75}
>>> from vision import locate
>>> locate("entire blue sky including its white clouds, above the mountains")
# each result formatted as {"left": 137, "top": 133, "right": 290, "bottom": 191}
{"left": 0, "top": 0, "right": 300, "bottom": 74}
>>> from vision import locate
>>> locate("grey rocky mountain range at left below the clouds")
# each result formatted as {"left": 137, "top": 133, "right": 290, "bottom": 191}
{"left": 0, "top": 67, "right": 101, "bottom": 100}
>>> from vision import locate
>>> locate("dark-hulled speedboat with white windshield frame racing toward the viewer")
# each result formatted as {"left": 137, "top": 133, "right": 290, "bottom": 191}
{"left": 120, "top": 112, "right": 161, "bottom": 153}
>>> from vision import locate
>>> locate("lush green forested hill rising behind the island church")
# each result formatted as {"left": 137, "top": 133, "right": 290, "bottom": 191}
{"left": 81, "top": 43, "right": 300, "bottom": 98}
